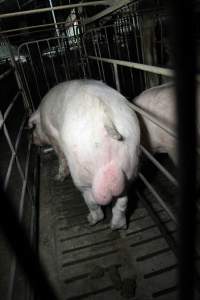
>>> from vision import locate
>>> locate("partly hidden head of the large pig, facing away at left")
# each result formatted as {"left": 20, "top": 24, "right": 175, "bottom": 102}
{"left": 28, "top": 111, "right": 48, "bottom": 146}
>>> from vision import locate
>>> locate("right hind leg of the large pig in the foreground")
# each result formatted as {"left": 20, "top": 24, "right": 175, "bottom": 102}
{"left": 111, "top": 196, "right": 128, "bottom": 230}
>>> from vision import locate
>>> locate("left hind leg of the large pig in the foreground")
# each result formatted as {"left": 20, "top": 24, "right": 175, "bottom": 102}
{"left": 83, "top": 190, "right": 104, "bottom": 225}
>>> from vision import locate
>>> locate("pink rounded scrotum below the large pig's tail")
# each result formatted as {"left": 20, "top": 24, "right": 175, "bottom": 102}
{"left": 92, "top": 161, "right": 125, "bottom": 205}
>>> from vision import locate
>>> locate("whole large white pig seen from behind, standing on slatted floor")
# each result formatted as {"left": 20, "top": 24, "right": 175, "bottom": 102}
{"left": 29, "top": 80, "right": 140, "bottom": 230}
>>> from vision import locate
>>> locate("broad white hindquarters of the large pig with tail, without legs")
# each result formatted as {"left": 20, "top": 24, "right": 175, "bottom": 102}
{"left": 61, "top": 81, "right": 140, "bottom": 205}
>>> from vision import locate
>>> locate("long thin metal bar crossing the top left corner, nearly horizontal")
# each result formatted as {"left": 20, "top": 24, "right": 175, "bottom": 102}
{"left": 0, "top": 0, "right": 109, "bottom": 19}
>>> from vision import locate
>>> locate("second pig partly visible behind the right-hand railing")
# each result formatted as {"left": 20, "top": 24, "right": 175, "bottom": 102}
{"left": 133, "top": 82, "right": 200, "bottom": 165}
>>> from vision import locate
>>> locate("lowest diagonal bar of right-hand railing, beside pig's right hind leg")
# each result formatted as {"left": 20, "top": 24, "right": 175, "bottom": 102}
{"left": 138, "top": 172, "right": 178, "bottom": 224}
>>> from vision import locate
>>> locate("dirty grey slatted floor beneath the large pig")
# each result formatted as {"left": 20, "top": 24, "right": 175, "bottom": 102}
{"left": 40, "top": 149, "right": 197, "bottom": 300}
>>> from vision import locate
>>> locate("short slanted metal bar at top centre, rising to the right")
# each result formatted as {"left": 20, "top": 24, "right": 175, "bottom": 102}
{"left": 83, "top": 0, "right": 134, "bottom": 25}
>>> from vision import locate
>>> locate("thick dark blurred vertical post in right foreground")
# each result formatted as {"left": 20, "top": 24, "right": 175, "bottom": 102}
{"left": 172, "top": 0, "right": 196, "bottom": 300}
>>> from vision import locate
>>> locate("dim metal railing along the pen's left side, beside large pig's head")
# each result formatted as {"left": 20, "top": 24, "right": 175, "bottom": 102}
{"left": 0, "top": 41, "right": 35, "bottom": 300}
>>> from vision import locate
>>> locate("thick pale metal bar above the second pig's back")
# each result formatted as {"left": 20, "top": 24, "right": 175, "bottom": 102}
{"left": 88, "top": 55, "right": 174, "bottom": 79}
